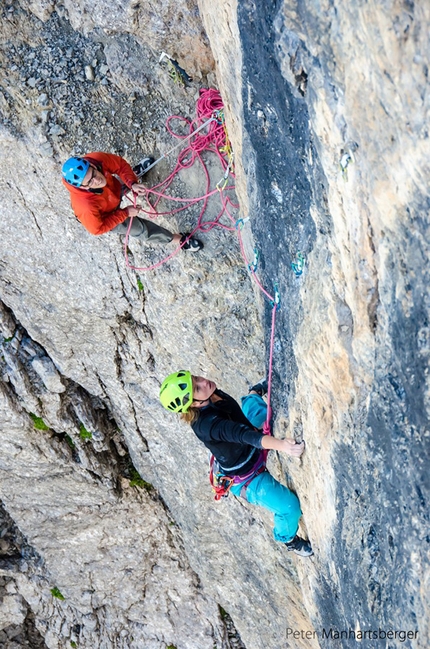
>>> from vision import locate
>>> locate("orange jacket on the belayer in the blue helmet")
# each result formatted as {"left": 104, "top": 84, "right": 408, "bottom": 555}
{"left": 63, "top": 152, "right": 137, "bottom": 234}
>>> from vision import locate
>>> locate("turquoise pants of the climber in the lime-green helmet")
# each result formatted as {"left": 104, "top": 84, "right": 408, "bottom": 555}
{"left": 231, "top": 394, "right": 302, "bottom": 543}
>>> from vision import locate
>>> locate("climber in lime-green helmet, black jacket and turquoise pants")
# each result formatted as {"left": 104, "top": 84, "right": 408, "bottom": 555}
{"left": 160, "top": 370, "right": 313, "bottom": 556}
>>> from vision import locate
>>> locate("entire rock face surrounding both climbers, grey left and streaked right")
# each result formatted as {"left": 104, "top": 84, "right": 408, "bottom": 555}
{"left": 0, "top": 0, "right": 430, "bottom": 649}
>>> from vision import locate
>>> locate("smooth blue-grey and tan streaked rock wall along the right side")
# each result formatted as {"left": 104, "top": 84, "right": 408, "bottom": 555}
{"left": 200, "top": 2, "right": 430, "bottom": 647}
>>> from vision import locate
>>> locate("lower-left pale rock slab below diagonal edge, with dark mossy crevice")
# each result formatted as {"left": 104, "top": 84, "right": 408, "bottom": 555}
{"left": 1, "top": 311, "right": 239, "bottom": 649}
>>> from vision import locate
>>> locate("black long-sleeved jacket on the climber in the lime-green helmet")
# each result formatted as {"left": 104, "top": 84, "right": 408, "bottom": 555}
{"left": 191, "top": 390, "right": 263, "bottom": 475}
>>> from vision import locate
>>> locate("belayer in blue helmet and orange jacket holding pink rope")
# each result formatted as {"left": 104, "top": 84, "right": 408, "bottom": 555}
{"left": 62, "top": 152, "right": 203, "bottom": 252}
